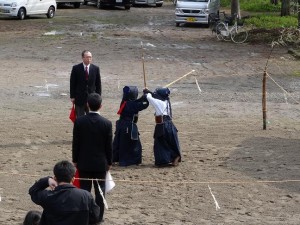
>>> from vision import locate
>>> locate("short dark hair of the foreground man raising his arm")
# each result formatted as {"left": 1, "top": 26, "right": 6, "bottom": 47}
{"left": 53, "top": 160, "right": 76, "bottom": 183}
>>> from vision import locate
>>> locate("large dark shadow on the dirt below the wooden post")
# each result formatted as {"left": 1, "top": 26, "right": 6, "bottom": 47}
{"left": 223, "top": 137, "right": 300, "bottom": 192}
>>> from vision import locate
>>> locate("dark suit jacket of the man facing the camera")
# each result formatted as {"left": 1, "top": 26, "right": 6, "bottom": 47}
{"left": 70, "top": 63, "right": 101, "bottom": 106}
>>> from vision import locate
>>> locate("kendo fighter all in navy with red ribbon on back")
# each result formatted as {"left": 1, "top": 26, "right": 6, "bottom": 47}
{"left": 113, "top": 86, "right": 149, "bottom": 166}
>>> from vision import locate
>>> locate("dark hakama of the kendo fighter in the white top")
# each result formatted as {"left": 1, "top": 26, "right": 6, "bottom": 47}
{"left": 153, "top": 116, "right": 181, "bottom": 166}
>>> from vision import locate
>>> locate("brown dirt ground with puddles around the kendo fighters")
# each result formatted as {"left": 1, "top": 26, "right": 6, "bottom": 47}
{"left": 0, "top": 3, "right": 300, "bottom": 225}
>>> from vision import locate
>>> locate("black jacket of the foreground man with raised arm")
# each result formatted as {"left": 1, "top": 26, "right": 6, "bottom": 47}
{"left": 29, "top": 177, "right": 100, "bottom": 225}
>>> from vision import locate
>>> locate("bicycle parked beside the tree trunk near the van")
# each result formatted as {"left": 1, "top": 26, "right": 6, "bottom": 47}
{"left": 216, "top": 14, "right": 248, "bottom": 44}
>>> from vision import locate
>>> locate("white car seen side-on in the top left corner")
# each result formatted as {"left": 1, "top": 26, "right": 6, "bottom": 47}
{"left": 0, "top": 0, "right": 56, "bottom": 20}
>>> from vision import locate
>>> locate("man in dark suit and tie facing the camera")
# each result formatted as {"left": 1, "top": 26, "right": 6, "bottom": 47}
{"left": 70, "top": 50, "right": 101, "bottom": 118}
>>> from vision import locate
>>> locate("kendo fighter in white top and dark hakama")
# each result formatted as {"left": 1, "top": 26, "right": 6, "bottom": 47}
{"left": 143, "top": 88, "right": 181, "bottom": 166}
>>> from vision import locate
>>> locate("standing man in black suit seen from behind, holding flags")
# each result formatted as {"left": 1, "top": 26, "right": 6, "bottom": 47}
{"left": 72, "top": 93, "right": 112, "bottom": 221}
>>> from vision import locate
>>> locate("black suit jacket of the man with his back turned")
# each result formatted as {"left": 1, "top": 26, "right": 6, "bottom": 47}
{"left": 72, "top": 112, "right": 112, "bottom": 172}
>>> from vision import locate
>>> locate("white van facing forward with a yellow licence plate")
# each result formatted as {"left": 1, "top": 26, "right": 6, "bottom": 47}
{"left": 175, "top": 0, "right": 220, "bottom": 27}
